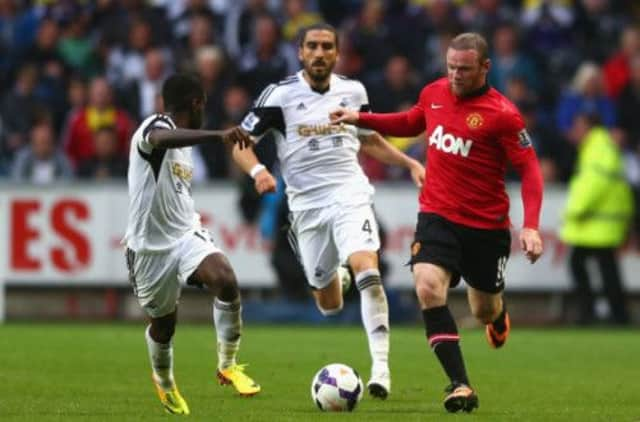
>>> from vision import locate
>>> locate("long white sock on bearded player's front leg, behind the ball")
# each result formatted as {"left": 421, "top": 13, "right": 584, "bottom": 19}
{"left": 356, "top": 269, "right": 389, "bottom": 367}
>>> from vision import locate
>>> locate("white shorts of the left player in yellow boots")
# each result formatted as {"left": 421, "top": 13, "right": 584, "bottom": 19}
{"left": 127, "top": 229, "right": 222, "bottom": 318}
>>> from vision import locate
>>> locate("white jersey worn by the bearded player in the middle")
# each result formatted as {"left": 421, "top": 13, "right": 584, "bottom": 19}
{"left": 242, "top": 71, "right": 373, "bottom": 211}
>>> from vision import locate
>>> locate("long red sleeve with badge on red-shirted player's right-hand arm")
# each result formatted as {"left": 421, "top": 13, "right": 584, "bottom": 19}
{"left": 498, "top": 111, "right": 543, "bottom": 229}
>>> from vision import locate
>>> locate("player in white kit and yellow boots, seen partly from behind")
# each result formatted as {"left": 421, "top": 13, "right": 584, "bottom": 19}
{"left": 123, "top": 75, "right": 260, "bottom": 414}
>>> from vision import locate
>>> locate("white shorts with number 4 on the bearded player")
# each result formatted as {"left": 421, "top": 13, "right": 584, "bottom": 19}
{"left": 290, "top": 204, "right": 380, "bottom": 289}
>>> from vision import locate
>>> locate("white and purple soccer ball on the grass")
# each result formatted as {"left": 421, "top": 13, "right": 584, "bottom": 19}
{"left": 311, "top": 363, "right": 363, "bottom": 412}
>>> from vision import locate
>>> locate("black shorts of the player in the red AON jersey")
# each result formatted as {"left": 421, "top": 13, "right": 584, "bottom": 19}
{"left": 409, "top": 212, "right": 511, "bottom": 293}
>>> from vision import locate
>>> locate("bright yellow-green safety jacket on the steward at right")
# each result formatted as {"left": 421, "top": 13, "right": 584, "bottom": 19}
{"left": 560, "top": 127, "right": 633, "bottom": 248}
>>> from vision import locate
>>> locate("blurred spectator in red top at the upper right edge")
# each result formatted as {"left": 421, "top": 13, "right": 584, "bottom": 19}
{"left": 602, "top": 26, "right": 640, "bottom": 99}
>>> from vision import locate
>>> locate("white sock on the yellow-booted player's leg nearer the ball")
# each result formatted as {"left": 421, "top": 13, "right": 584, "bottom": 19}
{"left": 213, "top": 298, "right": 242, "bottom": 369}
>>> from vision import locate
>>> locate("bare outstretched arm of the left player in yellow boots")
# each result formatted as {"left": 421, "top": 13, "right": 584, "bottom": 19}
{"left": 149, "top": 127, "right": 253, "bottom": 149}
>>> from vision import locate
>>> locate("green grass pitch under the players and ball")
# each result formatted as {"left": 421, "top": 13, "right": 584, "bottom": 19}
{"left": 0, "top": 323, "right": 640, "bottom": 422}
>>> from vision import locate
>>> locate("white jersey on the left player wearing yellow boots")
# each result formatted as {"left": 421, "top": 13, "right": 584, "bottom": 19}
{"left": 123, "top": 114, "right": 200, "bottom": 252}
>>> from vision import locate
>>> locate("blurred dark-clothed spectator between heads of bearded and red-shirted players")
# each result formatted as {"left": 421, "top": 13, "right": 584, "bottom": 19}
{"left": 369, "top": 56, "right": 422, "bottom": 113}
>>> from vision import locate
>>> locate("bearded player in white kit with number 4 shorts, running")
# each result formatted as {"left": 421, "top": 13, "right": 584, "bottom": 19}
{"left": 233, "top": 24, "right": 424, "bottom": 399}
